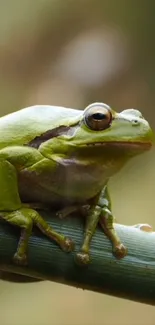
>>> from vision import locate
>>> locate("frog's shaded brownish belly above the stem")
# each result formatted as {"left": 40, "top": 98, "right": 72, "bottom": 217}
{"left": 19, "top": 161, "right": 112, "bottom": 205}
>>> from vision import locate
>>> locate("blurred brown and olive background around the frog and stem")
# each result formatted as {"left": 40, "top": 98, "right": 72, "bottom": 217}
{"left": 0, "top": 0, "right": 155, "bottom": 325}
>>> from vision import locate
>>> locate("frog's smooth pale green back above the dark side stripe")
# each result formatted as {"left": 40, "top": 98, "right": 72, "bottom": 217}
{"left": 0, "top": 105, "right": 82, "bottom": 148}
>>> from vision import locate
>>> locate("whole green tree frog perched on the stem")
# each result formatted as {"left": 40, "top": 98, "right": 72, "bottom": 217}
{"left": 0, "top": 102, "right": 154, "bottom": 266}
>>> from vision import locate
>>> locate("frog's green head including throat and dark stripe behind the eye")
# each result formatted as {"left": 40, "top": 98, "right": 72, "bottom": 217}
{"left": 38, "top": 103, "right": 154, "bottom": 163}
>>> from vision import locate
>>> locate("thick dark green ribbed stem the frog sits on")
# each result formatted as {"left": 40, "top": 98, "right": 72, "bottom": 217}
{"left": 0, "top": 212, "right": 155, "bottom": 305}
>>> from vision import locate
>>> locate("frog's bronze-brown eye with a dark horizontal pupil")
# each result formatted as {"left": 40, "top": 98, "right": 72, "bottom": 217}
{"left": 84, "top": 103, "right": 112, "bottom": 131}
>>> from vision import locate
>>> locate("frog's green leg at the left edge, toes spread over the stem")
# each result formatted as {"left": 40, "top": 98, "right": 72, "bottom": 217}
{"left": 0, "top": 160, "right": 74, "bottom": 264}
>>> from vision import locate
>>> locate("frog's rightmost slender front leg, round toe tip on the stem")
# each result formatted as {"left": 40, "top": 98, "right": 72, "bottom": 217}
{"left": 98, "top": 186, "right": 127, "bottom": 259}
